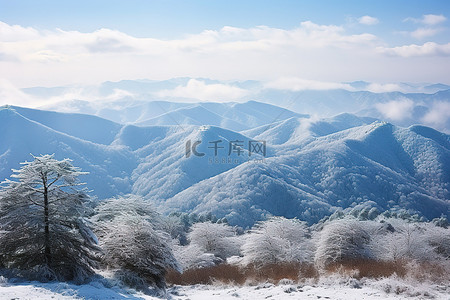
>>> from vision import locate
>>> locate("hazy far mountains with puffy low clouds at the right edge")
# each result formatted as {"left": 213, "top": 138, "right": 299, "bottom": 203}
{"left": 255, "top": 89, "right": 450, "bottom": 133}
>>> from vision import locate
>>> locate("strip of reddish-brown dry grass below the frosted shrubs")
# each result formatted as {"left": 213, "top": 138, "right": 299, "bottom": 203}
{"left": 166, "top": 259, "right": 449, "bottom": 285}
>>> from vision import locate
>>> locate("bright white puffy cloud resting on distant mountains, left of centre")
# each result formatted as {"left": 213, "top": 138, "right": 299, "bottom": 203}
{"left": 156, "top": 79, "right": 249, "bottom": 102}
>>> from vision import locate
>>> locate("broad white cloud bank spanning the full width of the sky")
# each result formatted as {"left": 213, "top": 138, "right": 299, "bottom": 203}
{"left": 0, "top": 21, "right": 449, "bottom": 88}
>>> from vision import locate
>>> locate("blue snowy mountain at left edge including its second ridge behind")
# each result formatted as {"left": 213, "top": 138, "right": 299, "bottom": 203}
{"left": 0, "top": 107, "right": 138, "bottom": 198}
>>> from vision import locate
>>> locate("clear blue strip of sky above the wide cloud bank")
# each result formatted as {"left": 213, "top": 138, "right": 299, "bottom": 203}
{"left": 0, "top": 0, "right": 450, "bottom": 38}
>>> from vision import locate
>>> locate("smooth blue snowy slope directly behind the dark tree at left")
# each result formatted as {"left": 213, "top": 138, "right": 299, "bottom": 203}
{"left": 0, "top": 108, "right": 138, "bottom": 198}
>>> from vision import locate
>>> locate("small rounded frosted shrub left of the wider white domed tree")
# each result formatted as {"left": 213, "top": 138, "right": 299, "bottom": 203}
{"left": 188, "top": 222, "right": 241, "bottom": 259}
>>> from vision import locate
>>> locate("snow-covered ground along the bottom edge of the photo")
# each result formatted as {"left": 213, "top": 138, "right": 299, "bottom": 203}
{"left": 0, "top": 278, "right": 450, "bottom": 300}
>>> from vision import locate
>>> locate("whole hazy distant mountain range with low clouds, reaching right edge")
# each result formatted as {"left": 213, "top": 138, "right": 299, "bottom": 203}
{"left": 29, "top": 78, "right": 450, "bottom": 133}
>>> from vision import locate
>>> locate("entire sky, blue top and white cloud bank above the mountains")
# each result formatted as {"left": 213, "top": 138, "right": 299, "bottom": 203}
{"left": 0, "top": 0, "right": 450, "bottom": 86}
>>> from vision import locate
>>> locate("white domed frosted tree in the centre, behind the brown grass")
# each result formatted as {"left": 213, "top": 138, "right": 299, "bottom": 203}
{"left": 242, "top": 217, "right": 311, "bottom": 266}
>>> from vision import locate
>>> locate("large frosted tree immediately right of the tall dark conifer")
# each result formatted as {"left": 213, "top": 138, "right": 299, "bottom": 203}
{"left": 92, "top": 195, "right": 179, "bottom": 290}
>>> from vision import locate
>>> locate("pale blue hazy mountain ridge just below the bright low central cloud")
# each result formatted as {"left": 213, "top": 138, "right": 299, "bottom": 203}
{"left": 44, "top": 99, "right": 308, "bottom": 131}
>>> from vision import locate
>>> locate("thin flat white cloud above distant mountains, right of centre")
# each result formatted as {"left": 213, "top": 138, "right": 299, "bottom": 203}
{"left": 265, "top": 77, "right": 354, "bottom": 92}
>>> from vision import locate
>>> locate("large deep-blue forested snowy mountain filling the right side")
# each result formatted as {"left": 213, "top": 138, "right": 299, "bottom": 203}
{"left": 161, "top": 123, "right": 450, "bottom": 225}
